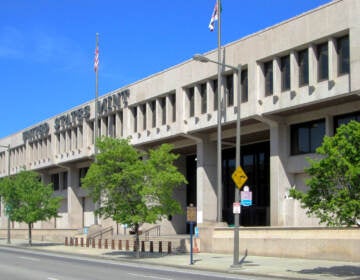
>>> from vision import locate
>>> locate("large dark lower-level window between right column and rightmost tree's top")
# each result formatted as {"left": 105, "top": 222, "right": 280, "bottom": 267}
{"left": 290, "top": 119, "right": 325, "bottom": 155}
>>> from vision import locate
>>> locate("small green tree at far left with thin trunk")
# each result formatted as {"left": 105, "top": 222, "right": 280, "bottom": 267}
{"left": 0, "top": 170, "right": 61, "bottom": 245}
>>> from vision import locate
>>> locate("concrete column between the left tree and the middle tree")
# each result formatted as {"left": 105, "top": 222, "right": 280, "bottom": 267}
{"left": 67, "top": 167, "right": 83, "bottom": 228}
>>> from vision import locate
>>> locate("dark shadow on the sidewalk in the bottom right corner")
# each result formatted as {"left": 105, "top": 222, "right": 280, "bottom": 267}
{"left": 288, "top": 265, "right": 360, "bottom": 280}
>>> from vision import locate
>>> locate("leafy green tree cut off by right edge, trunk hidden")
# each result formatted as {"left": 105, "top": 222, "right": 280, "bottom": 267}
{"left": 290, "top": 121, "right": 360, "bottom": 226}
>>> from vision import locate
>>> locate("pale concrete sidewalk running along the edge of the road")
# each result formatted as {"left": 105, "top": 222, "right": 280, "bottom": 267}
{"left": 0, "top": 238, "right": 360, "bottom": 280}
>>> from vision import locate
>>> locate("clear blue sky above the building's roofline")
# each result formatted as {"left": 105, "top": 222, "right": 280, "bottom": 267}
{"left": 0, "top": 0, "right": 330, "bottom": 138}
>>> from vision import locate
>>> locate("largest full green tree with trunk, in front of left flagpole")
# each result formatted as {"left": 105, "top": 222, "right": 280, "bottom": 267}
{"left": 82, "top": 137, "right": 187, "bottom": 257}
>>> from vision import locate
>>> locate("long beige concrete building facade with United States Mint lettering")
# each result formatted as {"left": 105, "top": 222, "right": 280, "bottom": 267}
{"left": 0, "top": 0, "right": 360, "bottom": 233}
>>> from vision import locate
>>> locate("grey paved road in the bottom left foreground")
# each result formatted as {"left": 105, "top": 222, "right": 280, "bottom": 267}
{"left": 0, "top": 248, "right": 274, "bottom": 280}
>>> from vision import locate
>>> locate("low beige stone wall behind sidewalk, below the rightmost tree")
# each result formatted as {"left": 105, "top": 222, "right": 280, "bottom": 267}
{"left": 199, "top": 227, "right": 360, "bottom": 262}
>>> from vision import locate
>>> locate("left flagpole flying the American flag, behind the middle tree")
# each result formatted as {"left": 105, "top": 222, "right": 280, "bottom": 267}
{"left": 94, "top": 33, "right": 99, "bottom": 225}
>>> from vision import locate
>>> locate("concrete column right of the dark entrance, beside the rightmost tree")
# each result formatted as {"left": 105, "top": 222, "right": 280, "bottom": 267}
{"left": 270, "top": 122, "right": 292, "bottom": 226}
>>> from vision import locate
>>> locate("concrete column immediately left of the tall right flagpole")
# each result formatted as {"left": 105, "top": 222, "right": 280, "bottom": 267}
{"left": 196, "top": 137, "right": 217, "bottom": 223}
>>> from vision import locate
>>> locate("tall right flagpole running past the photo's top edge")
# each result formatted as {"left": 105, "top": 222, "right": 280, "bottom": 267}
{"left": 217, "top": 0, "right": 223, "bottom": 223}
